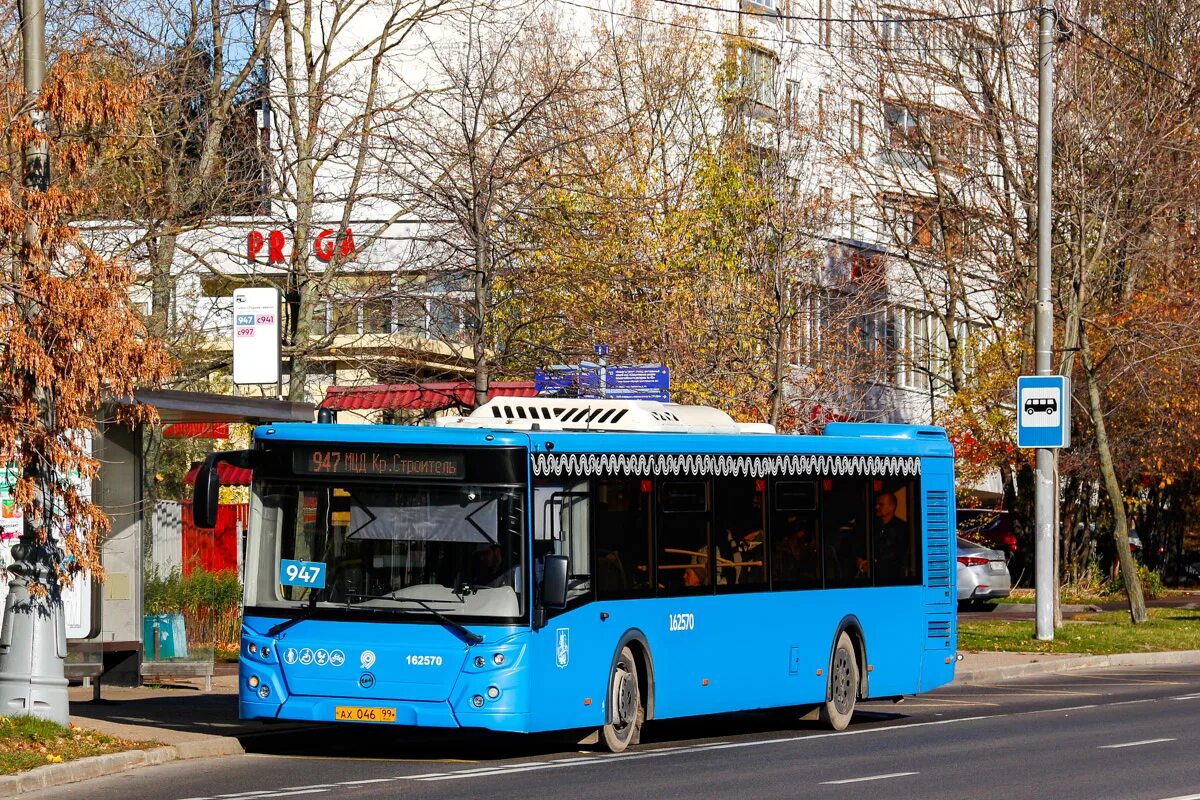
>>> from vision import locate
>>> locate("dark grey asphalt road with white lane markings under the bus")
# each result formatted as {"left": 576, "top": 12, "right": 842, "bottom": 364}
{"left": 22, "top": 667, "right": 1200, "bottom": 800}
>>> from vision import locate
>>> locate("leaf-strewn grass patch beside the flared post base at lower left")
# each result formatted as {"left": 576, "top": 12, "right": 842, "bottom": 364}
{"left": 0, "top": 716, "right": 157, "bottom": 775}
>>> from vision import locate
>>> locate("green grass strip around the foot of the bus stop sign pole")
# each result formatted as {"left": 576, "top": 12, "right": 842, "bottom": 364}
{"left": 959, "top": 608, "right": 1200, "bottom": 656}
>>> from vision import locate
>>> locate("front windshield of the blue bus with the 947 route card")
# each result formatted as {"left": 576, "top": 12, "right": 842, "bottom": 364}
{"left": 246, "top": 481, "right": 527, "bottom": 620}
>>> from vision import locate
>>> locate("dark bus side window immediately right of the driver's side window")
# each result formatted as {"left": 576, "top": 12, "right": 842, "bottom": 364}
{"left": 593, "top": 477, "right": 653, "bottom": 600}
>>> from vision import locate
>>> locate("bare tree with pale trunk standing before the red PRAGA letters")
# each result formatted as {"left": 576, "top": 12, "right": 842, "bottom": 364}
{"left": 269, "top": 0, "right": 450, "bottom": 399}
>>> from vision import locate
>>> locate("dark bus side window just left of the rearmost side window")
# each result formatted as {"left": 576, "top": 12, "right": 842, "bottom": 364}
{"left": 821, "top": 477, "right": 871, "bottom": 588}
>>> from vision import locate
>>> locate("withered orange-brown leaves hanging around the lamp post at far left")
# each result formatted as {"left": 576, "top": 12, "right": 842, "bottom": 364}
{"left": 0, "top": 54, "right": 170, "bottom": 582}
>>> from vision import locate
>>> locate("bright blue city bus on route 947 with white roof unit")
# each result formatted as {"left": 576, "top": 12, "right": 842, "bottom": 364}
{"left": 194, "top": 398, "right": 956, "bottom": 752}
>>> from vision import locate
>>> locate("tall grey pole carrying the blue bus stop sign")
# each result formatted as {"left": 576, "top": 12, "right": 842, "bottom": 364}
{"left": 1032, "top": 0, "right": 1070, "bottom": 642}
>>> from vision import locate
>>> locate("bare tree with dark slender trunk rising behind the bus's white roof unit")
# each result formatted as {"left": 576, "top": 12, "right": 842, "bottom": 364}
{"left": 388, "top": 1, "right": 593, "bottom": 404}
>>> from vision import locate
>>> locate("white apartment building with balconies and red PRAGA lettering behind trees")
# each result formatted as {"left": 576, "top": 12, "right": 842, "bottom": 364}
{"left": 114, "top": 0, "right": 1032, "bottom": 431}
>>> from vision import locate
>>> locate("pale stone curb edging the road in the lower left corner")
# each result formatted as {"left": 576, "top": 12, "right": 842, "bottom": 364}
{"left": 0, "top": 736, "right": 246, "bottom": 798}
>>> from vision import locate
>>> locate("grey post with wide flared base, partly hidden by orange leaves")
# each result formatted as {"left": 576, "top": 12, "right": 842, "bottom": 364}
{"left": 0, "top": 0, "right": 71, "bottom": 726}
